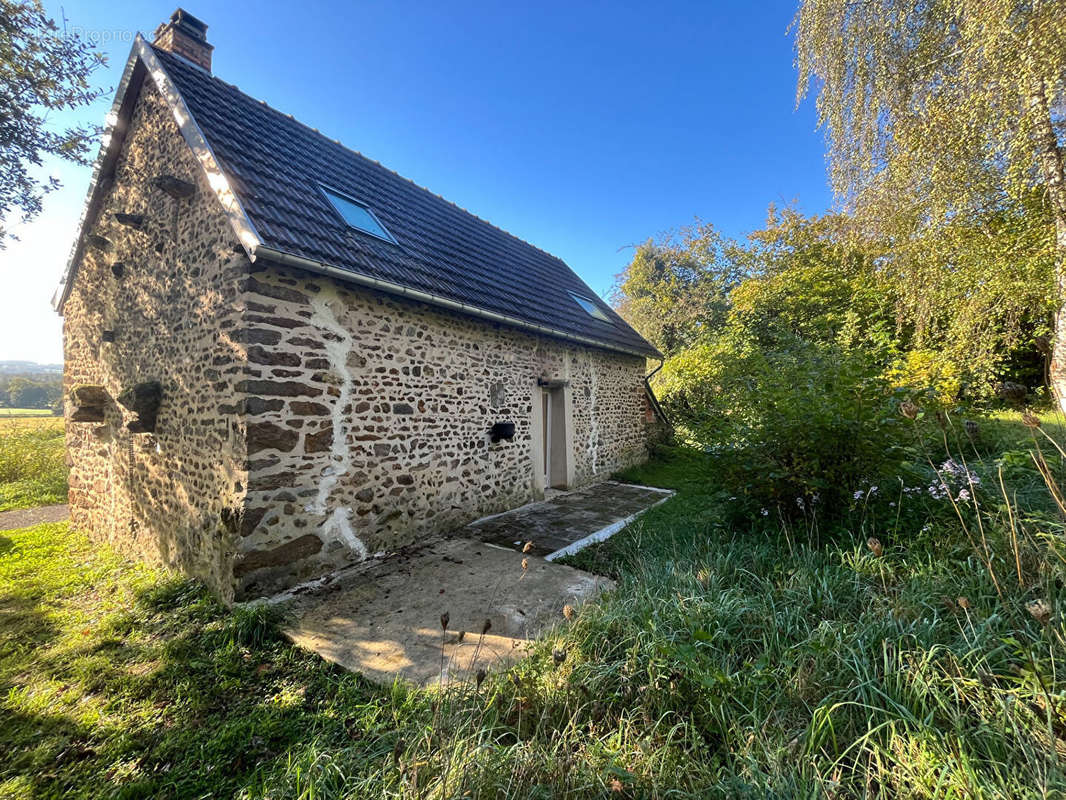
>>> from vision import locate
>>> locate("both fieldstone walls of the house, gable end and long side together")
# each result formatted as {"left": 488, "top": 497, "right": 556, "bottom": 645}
{"left": 64, "top": 81, "right": 647, "bottom": 601}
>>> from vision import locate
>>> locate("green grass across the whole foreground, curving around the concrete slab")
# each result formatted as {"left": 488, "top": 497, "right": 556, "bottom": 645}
{"left": 0, "top": 420, "right": 1066, "bottom": 798}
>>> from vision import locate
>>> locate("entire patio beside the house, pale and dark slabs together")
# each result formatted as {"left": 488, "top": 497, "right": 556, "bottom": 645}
{"left": 278, "top": 482, "right": 671, "bottom": 685}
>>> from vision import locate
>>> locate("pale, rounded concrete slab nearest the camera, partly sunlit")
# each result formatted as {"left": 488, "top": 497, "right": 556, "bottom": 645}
{"left": 286, "top": 538, "right": 613, "bottom": 686}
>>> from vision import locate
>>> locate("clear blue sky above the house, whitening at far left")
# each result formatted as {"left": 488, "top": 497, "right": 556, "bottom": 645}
{"left": 0, "top": 0, "right": 831, "bottom": 362}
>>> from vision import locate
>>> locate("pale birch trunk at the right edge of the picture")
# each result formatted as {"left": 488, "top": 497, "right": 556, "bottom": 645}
{"left": 1029, "top": 80, "right": 1066, "bottom": 412}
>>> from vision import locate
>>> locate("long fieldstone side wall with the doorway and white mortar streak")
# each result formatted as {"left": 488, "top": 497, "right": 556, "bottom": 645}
{"left": 235, "top": 267, "right": 646, "bottom": 595}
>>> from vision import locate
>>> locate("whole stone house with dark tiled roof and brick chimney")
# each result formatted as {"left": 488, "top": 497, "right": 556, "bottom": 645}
{"left": 54, "top": 10, "right": 660, "bottom": 601}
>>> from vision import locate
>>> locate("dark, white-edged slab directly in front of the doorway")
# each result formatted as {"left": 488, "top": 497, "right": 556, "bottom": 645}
{"left": 456, "top": 481, "right": 674, "bottom": 561}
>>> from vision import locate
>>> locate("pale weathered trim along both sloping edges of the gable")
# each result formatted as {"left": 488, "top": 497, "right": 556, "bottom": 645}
{"left": 52, "top": 33, "right": 260, "bottom": 314}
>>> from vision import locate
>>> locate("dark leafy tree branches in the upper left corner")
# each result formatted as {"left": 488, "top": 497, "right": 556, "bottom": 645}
{"left": 0, "top": 0, "right": 104, "bottom": 246}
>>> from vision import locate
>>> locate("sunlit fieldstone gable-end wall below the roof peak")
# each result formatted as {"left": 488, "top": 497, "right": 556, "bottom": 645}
{"left": 63, "top": 73, "right": 248, "bottom": 598}
